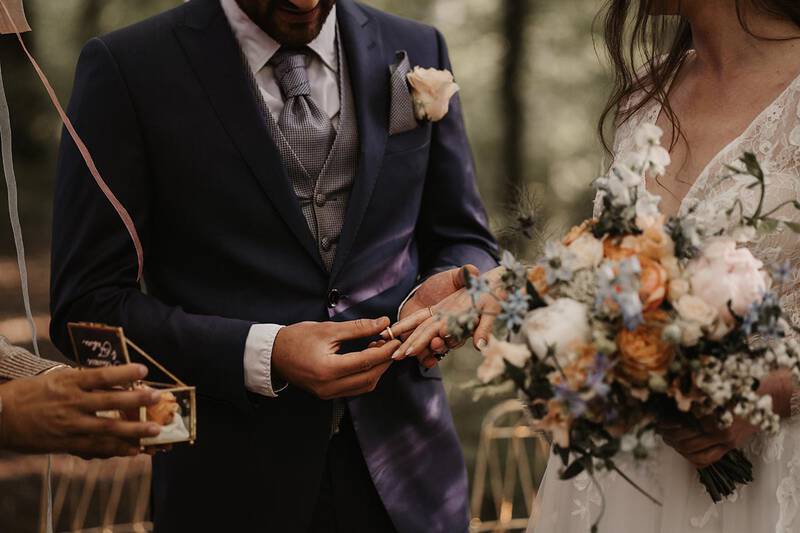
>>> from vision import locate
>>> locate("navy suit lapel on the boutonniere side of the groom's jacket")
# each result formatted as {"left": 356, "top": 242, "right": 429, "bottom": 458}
{"left": 331, "top": 0, "right": 389, "bottom": 282}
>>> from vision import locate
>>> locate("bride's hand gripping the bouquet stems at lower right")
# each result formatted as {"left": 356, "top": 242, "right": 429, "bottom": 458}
{"left": 657, "top": 417, "right": 758, "bottom": 469}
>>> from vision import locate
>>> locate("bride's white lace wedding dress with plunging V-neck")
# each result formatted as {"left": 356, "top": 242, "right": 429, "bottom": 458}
{"left": 529, "top": 70, "right": 800, "bottom": 533}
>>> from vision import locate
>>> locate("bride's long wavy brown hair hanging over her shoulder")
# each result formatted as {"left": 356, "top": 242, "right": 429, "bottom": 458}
{"left": 598, "top": 0, "right": 800, "bottom": 151}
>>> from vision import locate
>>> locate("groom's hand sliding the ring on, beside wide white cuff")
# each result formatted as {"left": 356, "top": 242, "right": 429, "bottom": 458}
{"left": 272, "top": 318, "right": 400, "bottom": 400}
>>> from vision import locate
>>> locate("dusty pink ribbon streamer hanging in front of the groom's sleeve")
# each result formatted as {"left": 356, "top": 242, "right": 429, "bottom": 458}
{"left": 0, "top": 0, "right": 144, "bottom": 281}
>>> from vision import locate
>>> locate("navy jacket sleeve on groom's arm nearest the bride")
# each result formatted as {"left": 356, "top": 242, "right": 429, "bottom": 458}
{"left": 417, "top": 31, "right": 498, "bottom": 278}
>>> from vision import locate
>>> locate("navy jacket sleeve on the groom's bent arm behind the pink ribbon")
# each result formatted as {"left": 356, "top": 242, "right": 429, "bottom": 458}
{"left": 51, "top": 39, "right": 252, "bottom": 409}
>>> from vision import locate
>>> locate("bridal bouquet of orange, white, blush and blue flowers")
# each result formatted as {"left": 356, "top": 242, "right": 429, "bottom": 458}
{"left": 456, "top": 126, "right": 800, "bottom": 528}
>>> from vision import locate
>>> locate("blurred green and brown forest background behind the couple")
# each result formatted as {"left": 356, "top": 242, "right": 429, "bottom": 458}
{"left": 0, "top": 0, "right": 609, "bottom": 533}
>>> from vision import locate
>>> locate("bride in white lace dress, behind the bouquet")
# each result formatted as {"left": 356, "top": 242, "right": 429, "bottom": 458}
{"left": 393, "top": 0, "right": 800, "bottom": 533}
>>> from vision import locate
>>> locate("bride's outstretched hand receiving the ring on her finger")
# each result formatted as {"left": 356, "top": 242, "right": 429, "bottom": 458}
{"left": 384, "top": 267, "right": 503, "bottom": 366}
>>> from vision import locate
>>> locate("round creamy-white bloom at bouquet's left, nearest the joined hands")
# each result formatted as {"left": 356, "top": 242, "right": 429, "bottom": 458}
{"left": 522, "top": 298, "right": 592, "bottom": 366}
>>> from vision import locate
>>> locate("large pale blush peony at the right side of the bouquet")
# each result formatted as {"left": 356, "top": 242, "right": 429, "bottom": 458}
{"left": 688, "top": 237, "right": 767, "bottom": 326}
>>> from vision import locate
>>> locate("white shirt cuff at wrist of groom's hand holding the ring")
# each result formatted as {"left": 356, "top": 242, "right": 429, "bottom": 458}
{"left": 244, "top": 324, "right": 288, "bottom": 398}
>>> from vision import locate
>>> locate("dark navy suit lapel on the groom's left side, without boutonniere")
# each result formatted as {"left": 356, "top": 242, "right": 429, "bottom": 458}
{"left": 175, "top": 0, "right": 324, "bottom": 269}
